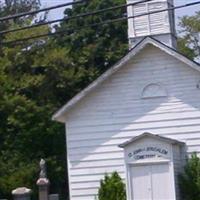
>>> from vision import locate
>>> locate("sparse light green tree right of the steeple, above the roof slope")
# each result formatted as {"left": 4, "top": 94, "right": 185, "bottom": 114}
{"left": 178, "top": 11, "right": 200, "bottom": 59}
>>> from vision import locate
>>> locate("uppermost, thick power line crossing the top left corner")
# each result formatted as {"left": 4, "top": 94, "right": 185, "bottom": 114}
{"left": 0, "top": 0, "right": 86, "bottom": 22}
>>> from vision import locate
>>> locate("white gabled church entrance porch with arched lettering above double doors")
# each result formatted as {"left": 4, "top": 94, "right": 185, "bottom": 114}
{"left": 119, "top": 133, "right": 186, "bottom": 200}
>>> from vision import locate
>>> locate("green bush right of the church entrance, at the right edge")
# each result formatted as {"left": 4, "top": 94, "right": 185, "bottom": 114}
{"left": 179, "top": 154, "right": 200, "bottom": 200}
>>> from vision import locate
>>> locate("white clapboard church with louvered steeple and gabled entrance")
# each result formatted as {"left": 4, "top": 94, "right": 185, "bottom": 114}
{"left": 53, "top": 0, "right": 200, "bottom": 200}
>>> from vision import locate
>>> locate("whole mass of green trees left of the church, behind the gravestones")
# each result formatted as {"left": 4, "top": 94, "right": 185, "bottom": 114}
{"left": 0, "top": 0, "right": 127, "bottom": 199}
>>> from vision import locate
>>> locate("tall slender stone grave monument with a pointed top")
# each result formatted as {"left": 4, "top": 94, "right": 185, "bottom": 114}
{"left": 37, "top": 159, "right": 50, "bottom": 200}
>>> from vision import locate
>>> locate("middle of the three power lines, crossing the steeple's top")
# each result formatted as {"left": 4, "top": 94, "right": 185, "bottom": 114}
{"left": 0, "top": 0, "right": 152, "bottom": 35}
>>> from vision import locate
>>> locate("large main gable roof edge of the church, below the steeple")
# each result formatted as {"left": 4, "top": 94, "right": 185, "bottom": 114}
{"left": 52, "top": 37, "right": 200, "bottom": 123}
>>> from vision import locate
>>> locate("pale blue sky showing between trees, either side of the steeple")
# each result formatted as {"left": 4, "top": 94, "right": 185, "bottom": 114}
{"left": 41, "top": 0, "right": 200, "bottom": 22}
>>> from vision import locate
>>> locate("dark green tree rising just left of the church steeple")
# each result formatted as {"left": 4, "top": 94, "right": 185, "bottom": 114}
{"left": 55, "top": 0, "right": 128, "bottom": 73}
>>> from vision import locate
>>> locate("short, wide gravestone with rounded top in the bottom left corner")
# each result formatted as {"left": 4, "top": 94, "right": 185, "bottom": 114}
{"left": 12, "top": 187, "right": 31, "bottom": 200}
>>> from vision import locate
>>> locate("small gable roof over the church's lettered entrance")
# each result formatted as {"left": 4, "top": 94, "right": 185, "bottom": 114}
{"left": 119, "top": 132, "right": 185, "bottom": 148}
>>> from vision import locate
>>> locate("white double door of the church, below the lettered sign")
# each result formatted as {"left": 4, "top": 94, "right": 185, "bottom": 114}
{"left": 130, "top": 163, "right": 175, "bottom": 200}
